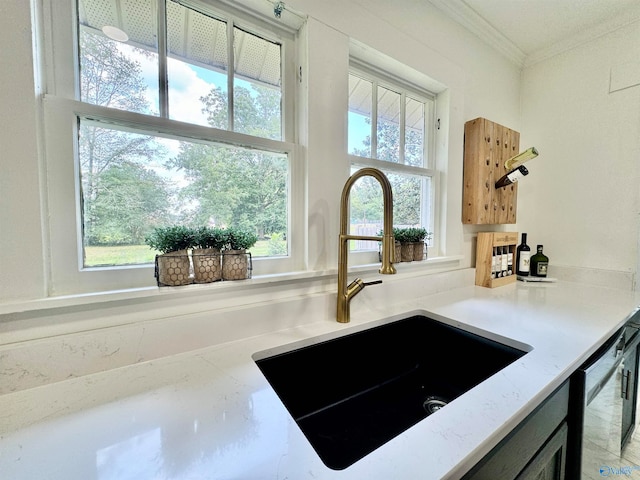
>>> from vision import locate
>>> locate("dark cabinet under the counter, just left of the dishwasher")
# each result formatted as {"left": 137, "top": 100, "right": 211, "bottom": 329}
{"left": 463, "top": 382, "right": 569, "bottom": 480}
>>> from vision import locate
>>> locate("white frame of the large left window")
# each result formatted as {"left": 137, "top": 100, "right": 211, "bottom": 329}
{"left": 42, "top": 0, "right": 306, "bottom": 295}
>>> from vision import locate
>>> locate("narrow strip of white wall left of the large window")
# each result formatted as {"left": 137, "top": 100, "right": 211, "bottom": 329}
{"left": 0, "top": 0, "right": 45, "bottom": 302}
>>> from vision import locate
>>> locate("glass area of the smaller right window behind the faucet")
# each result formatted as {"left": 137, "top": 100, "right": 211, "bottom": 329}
{"left": 348, "top": 69, "right": 435, "bottom": 255}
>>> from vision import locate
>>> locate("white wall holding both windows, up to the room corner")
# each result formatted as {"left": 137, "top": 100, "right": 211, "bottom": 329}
{"left": 0, "top": 0, "right": 520, "bottom": 305}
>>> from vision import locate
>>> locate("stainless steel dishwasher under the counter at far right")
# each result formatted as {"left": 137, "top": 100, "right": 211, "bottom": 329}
{"left": 573, "top": 311, "right": 640, "bottom": 480}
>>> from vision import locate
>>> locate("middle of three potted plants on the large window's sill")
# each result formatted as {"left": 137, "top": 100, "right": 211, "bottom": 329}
{"left": 191, "top": 227, "right": 227, "bottom": 283}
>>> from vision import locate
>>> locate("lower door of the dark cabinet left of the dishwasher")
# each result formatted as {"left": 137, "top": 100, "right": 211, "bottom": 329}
{"left": 516, "top": 422, "right": 568, "bottom": 480}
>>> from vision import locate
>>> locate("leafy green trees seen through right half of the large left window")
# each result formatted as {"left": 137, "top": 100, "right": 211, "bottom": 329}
{"left": 168, "top": 85, "right": 288, "bottom": 237}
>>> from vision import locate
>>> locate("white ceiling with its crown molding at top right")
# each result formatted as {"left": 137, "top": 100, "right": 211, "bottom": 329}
{"left": 429, "top": 0, "right": 640, "bottom": 64}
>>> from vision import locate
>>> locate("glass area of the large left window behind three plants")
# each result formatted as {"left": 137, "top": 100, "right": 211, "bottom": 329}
{"left": 72, "top": 0, "right": 292, "bottom": 270}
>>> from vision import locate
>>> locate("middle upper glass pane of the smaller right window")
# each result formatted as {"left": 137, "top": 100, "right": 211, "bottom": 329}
{"left": 376, "top": 87, "right": 400, "bottom": 163}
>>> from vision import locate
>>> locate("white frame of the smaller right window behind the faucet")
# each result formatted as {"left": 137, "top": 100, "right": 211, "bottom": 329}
{"left": 347, "top": 61, "right": 441, "bottom": 264}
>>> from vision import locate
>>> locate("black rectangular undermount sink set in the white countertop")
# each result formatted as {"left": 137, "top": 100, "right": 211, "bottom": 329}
{"left": 254, "top": 315, "right": 526, "bottom": 470}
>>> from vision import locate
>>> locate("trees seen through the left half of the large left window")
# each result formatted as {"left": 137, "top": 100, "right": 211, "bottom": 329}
{"left": 79, "top": 30, "right": 169, "bottom": 245}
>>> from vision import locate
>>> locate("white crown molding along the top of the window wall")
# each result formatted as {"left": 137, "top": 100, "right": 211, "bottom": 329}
{"left": 429, "top": 0, "right": 526, "bottom": 67}
